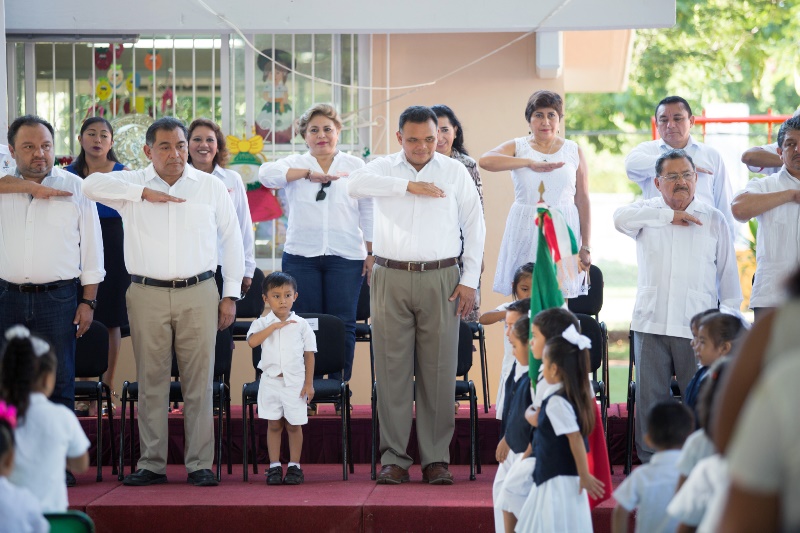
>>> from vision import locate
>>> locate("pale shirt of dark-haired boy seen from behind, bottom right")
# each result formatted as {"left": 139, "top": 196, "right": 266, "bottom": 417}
{"left": 614, "top": 450, "right": 680, "bottom": 533}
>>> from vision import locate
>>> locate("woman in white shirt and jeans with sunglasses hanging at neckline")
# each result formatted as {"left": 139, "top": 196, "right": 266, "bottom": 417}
{"left": 258, "top": 104, "right": 374, "bottom": 381}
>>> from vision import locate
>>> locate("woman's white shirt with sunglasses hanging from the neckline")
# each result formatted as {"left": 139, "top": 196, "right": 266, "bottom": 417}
{"left": 258, "top": 152, "right": 373, "bottom": 260}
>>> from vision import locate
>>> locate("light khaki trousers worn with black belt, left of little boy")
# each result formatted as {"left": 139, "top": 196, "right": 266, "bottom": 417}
{"left": 126, "top": 278, "right": 219, "bottom": 474}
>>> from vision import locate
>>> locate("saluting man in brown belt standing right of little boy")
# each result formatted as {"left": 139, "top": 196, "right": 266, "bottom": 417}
{"left": 348, "top": 106, "right": 486, "bottom": 485}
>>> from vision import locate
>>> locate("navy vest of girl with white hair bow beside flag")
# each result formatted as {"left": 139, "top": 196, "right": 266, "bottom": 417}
{"left": 533, "top": 389, "right": 589, "bottom": 486}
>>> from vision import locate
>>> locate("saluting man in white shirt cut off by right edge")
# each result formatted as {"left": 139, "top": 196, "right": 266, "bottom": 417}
{"left": 731, "top": 116, "right": 800, "bottom": 320}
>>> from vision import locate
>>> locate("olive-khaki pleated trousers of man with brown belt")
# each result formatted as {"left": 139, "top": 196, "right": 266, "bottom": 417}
{"left": 370, "top": 265, "right": 460, "bottom": 469}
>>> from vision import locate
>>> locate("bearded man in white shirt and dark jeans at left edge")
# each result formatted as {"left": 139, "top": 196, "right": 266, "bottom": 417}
{"left": 0, "top": 115, "right": 105, "bottom": 409}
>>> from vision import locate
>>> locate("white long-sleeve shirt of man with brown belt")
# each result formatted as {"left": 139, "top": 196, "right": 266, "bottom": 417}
{"left": 347, "top": 152, "right": 486, "bottom": 289}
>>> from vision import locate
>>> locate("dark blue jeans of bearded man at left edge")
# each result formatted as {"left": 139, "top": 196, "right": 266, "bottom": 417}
{"left": 0, "top": 283, "right": 78, "bottom": 410}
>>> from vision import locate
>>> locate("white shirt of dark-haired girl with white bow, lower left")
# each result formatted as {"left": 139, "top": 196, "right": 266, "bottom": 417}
{"left": 9, "top": 392, "right": 89, "bottom": 513}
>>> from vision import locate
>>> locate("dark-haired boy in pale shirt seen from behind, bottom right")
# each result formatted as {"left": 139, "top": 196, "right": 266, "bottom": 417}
{"left": 611, "top": 400, "right": 694, "bottom": 533}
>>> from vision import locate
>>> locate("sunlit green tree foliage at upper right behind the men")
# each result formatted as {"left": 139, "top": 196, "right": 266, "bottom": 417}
{"left": 566, "top": 0, "right": 800, "bottom": 153}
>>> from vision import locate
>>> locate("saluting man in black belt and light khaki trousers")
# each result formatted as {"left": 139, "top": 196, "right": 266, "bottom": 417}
{"left": 83, "top": 117, "right": 244, "bottom": 486}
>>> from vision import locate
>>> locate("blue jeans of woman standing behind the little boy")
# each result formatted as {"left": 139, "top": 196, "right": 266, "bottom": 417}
{"left": 283, "top": 252, "right": 364, "bottom": 381}
